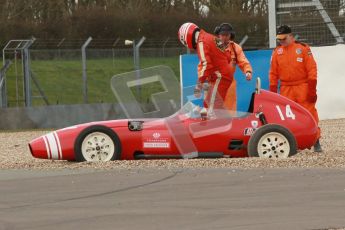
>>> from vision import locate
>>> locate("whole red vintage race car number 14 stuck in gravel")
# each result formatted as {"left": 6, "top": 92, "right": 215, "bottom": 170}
{"left": 29, "top": 80, "right": 318, "bottom": 161}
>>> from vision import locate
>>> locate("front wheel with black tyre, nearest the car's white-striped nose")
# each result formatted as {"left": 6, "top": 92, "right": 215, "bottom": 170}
{"left": 74, "top": 125, "right": 121, "bottom": 162}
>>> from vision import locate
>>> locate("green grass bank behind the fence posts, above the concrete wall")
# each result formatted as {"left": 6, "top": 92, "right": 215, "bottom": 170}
{"left": 2, "top": 57, "right": 179, "bottom": 107}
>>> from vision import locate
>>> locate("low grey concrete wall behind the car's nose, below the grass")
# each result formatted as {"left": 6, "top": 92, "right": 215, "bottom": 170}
{"left": 0, "top": 104, "right": 125, "bottom": 130}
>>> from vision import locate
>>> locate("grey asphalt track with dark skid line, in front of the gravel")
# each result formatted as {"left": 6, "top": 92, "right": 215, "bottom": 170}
{"left": 0, "top": 169, "right": 345, "bottom": 230}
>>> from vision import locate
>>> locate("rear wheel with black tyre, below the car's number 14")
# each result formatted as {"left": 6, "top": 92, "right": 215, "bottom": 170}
{"left": 248, "top": 124, "right": 297, "bottom": 158}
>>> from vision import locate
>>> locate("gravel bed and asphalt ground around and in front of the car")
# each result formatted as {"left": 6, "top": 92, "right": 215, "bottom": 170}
{"left": 0, "top": 119, "right": 345, "bottom": 230}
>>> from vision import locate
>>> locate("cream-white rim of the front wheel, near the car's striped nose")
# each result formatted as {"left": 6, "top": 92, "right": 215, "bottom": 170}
{"left": 81, "top": 132, "right": 115, "bottom": 162}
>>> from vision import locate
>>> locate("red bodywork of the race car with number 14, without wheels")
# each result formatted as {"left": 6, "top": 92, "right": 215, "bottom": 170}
{"left": 29, "top": 90, "right": 318, "bottom": 160}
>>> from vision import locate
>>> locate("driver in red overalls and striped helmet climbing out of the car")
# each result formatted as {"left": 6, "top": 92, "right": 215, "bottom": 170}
{"left": 178, "top": 23, "right": 251, "bottom": 114}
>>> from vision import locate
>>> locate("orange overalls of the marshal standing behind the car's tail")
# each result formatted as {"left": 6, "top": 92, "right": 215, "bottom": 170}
{"left": 269, "top": 41, "right": 320, "bottom": 137}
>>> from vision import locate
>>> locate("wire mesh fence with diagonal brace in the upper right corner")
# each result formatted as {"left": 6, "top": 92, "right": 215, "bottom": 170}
{"left": 276, "top": 0, "right": 345, "bottom": 46}
